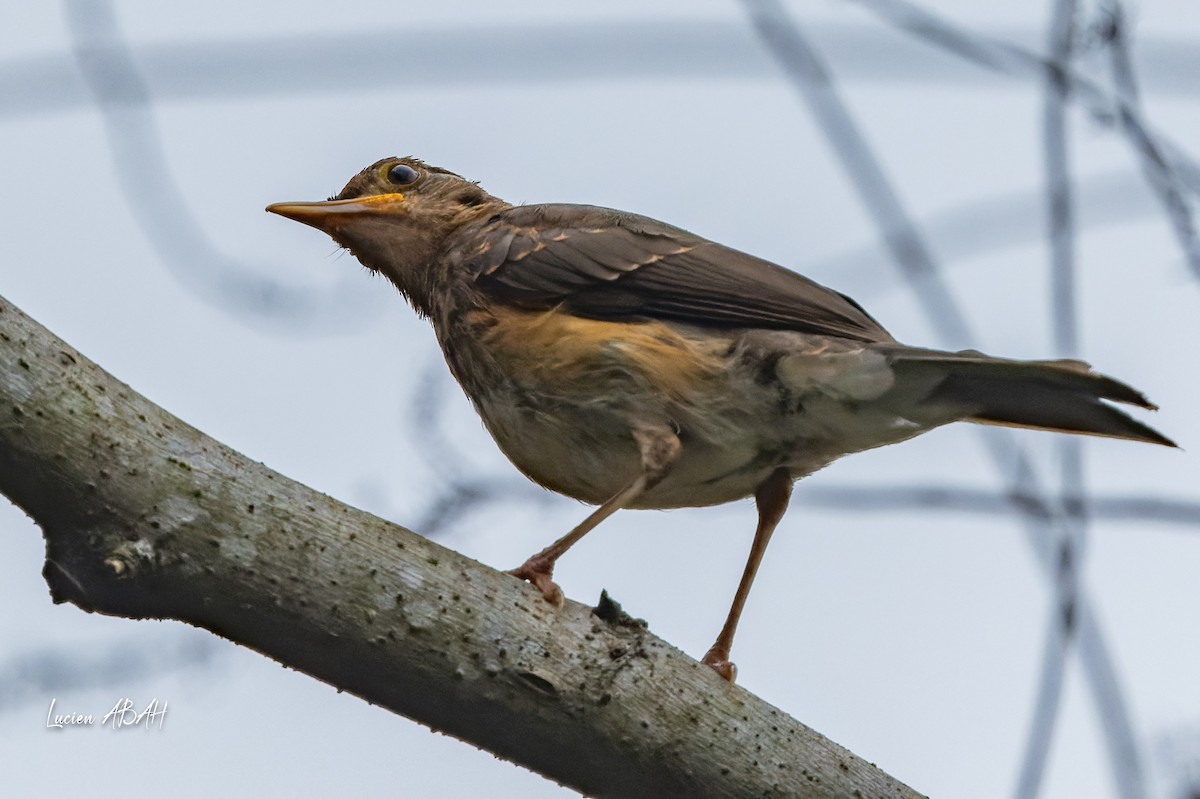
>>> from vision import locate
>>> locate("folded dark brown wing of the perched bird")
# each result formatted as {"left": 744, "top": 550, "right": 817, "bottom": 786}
{"left": 463, "top": 205, "right": 892, "bottom": 342}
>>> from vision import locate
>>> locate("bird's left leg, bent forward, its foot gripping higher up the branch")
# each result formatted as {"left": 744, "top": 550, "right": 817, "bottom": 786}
{"left": 509, "top": 427, "right": 682, "bottom": 607}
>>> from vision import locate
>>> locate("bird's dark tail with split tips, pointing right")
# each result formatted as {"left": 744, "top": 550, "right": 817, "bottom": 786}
{"left": 887, "top": 348, "right": 1176, "bottom": 446}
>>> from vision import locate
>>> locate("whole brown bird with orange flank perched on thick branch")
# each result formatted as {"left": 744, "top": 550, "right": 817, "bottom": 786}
{"left": 266, "top": 156, "right": 1176, "bottom": 681}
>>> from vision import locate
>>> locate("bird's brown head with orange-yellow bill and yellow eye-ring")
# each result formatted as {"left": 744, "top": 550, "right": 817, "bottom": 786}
{"left": 266, "top": 157, "right": 509, "bottom": 311}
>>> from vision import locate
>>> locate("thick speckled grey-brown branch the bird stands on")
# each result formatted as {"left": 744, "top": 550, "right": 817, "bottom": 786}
{"left": 0, "top": 298, "right": 917, "bottom": 797}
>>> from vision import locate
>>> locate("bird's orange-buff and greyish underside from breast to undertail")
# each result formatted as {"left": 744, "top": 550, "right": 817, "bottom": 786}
{"left": 460, "top": 311, "right": 931, "bottom": 509}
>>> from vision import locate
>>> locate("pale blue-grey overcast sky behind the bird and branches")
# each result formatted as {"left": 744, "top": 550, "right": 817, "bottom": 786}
{"left": 0, "top": 0, "right": 1200, "bottom": 798}
